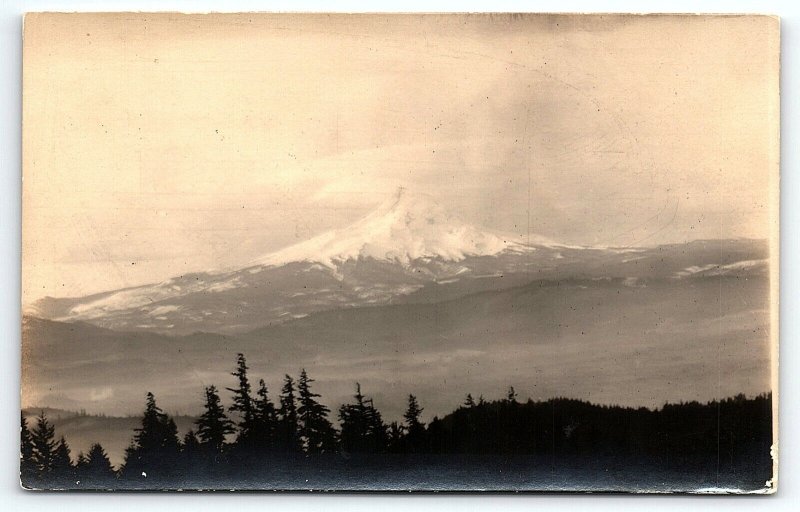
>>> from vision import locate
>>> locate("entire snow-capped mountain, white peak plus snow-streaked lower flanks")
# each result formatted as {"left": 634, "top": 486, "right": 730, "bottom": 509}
{"left": 26, "top": 186, "right": 768, "bottom": 335}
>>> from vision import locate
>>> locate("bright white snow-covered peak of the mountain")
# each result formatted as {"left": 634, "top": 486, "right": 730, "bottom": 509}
{"left": 253, "top": 188, "right": 526, "bottom": 268}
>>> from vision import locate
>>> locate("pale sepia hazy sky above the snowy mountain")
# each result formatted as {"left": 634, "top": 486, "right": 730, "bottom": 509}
{"left": 23, "top": 14, "right": 779, "bottom": 301}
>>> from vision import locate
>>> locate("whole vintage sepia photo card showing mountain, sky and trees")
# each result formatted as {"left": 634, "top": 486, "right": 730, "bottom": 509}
{"left": 21, "top": 13, "right": 780, "bottom": 494}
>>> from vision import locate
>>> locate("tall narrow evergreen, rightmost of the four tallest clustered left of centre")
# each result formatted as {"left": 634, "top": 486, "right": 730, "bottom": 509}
{"left": 297, "top": 369, "right": 336, "bottom": 453}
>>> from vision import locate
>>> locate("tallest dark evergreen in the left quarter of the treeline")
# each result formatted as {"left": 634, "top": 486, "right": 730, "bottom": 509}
{"left": 120, "top": 393, "right": 180, "bottom": 478}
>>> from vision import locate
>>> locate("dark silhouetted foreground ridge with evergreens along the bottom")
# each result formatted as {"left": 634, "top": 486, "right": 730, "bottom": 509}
{"left": 20, "top": 354, "right": 772, "bottom": 492}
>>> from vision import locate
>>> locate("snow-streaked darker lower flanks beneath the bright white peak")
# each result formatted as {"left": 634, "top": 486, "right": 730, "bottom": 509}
{"left": 25, "top": 240, "right": 769, "bottom": 334}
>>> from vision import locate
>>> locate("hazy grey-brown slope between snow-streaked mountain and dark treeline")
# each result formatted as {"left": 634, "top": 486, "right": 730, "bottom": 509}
{"left": 23, "top": 270, "right": 770, "bottom": 418}
